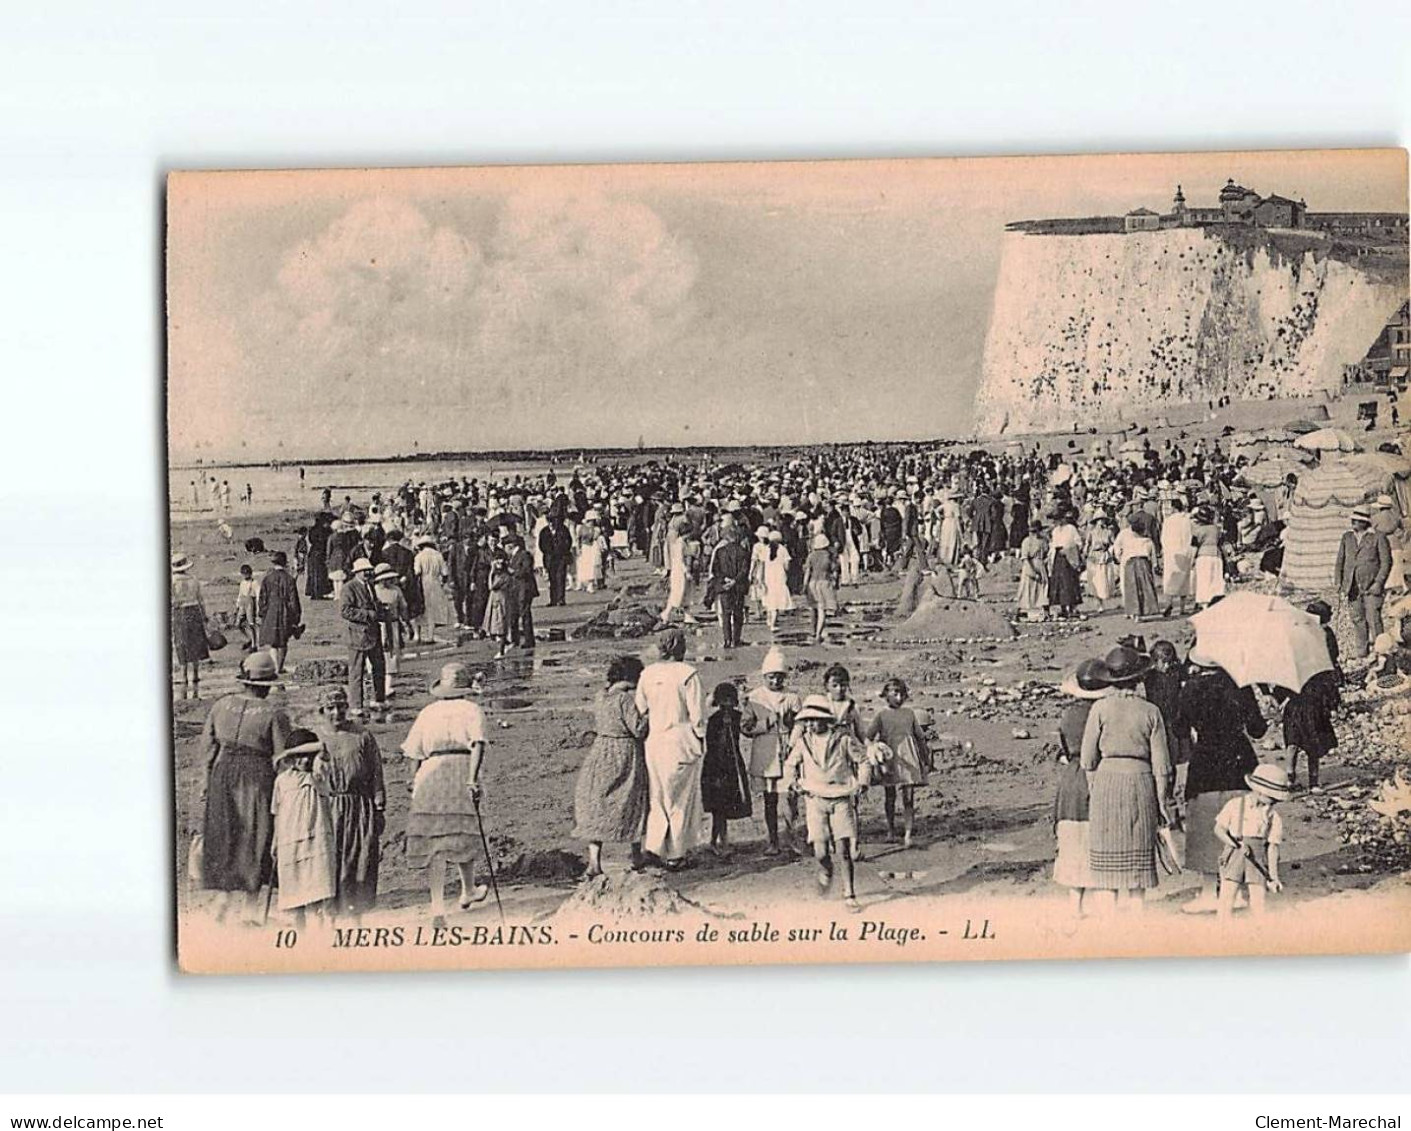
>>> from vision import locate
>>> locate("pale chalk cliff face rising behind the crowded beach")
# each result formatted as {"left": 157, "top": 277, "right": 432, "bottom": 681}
{"left": 975, "top": 228, "right": 1407, "bottom": 436}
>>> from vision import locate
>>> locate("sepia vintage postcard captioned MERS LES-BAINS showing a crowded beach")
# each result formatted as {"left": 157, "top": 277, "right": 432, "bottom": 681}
{"left": 166, "top": 149, "right": 1411, "bottom": 973}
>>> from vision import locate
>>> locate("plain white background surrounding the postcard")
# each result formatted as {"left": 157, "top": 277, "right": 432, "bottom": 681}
{"left": 0, "top": 0, "right": 1411, "bottom": 1092}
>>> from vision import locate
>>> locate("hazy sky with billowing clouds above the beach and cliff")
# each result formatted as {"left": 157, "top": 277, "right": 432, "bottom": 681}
{"left": 166, "top": 149, "right": 1407, "bottom": 463}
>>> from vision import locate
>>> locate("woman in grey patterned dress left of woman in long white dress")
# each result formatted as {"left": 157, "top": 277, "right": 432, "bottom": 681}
{"left": 573, "top": 656, "right": 648, "bottom": 877}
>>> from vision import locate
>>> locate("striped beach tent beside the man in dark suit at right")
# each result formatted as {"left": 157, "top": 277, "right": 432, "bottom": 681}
{"left": 1278, "top": 453, "right": 1377, "bottom": 592}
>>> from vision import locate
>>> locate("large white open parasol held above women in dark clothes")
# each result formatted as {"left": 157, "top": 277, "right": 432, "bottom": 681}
{"left": 1191, "top": 592, "right": 1332, "bottom": 691}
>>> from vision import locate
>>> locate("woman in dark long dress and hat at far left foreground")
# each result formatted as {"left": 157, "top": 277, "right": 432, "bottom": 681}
{"left": 202, "top": 652, "right": 293, "bottom": 924}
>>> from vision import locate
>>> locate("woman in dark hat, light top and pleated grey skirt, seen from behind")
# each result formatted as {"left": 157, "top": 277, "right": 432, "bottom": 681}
{"left": 1082, "top": 646, "right": 1174, "bottom": 911}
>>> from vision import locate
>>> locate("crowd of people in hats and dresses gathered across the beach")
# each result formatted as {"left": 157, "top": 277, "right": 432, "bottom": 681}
{"left": 172, "top": 428, "right": 1404, "bottom": 918}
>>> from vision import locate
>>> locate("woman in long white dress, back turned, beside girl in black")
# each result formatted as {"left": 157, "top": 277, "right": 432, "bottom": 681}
{"left": 636, "top": 629, "right": 707, "bottom": 870}
